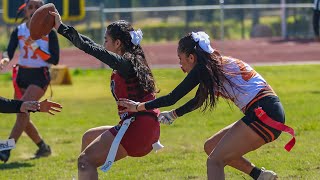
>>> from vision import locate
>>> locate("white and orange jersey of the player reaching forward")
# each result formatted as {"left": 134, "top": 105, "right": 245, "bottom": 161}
{"left": 217, "top": 56, "right": 275, "bottom": 111}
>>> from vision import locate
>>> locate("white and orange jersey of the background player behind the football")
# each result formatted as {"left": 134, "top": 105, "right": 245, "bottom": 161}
{"left": 18, "top": 23, "right": 49, "bottom": 67}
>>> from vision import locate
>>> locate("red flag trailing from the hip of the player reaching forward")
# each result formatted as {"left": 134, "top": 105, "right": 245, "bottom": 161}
{"left": 254, "top": 107, "right": 296, "bottom": 152}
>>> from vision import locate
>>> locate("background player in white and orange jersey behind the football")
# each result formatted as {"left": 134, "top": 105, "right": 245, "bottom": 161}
{"left": 0, "top": 0, "right": 59, "bottom": 162}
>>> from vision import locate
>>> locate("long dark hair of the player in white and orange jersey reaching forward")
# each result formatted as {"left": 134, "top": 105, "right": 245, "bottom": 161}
{"left": 178, "top": 33, "right": 232, "bottom": 111}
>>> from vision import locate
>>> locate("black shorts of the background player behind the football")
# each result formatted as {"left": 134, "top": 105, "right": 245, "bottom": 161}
{"left": 16, "top": 66, "right": 50, "bottom": 89}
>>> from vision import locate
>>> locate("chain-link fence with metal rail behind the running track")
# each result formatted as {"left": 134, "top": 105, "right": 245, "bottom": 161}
{"left": 0, "top": 3, "right": 313, "bottom": 47}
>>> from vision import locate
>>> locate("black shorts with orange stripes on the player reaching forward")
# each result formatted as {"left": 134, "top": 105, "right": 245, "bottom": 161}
{"left": 242, "top": 96, "right": 285, "bottom": 143}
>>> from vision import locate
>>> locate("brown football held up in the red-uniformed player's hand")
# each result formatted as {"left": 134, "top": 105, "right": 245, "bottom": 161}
{"left": 30, "top": 3, "right": 56, "bottom": 40}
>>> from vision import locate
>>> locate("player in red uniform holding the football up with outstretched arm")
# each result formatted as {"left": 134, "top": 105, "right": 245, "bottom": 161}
{"left": 50, "top": 12, "right": 161, "bottom": 180}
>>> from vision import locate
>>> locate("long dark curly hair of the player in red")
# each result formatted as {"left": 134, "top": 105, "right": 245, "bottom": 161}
{"left": 107, "top": 20, "right": 157, "bottom": 93}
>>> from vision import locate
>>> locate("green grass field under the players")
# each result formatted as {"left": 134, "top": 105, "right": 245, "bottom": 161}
{"left": 0, "top": 65, "right": 320, "bottom": 180}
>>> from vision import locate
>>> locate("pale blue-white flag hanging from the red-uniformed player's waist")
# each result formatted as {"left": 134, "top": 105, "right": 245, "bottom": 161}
{"left": 100, "top": 117, "right": 135, "bottom": 172}
